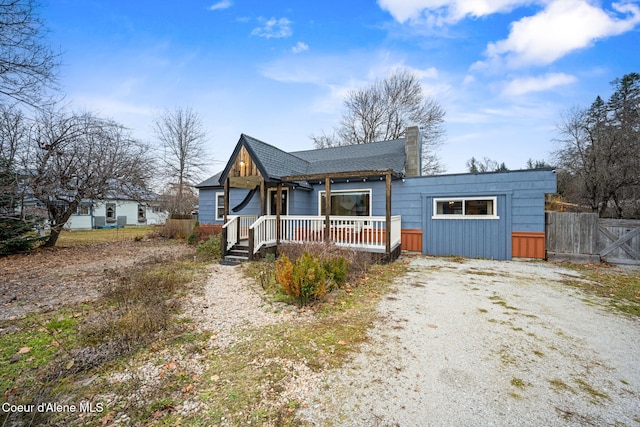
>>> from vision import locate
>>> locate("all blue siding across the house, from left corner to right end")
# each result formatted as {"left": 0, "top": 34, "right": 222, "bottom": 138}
{"left": 200, "top": 170, "right": 556, "bottom": 259}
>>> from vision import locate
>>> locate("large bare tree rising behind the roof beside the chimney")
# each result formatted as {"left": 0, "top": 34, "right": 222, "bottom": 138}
{"left": 311, "top": 70, "right": 445, "bottom": 174}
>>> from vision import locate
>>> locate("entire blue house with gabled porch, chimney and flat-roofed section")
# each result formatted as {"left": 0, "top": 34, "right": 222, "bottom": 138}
{"left": 196, "top": 127, "right": 556, "bottom": 260}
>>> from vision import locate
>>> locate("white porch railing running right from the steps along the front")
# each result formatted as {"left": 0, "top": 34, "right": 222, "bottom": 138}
{"left": 249, "top": 215, "right": 401, "bottom": 253}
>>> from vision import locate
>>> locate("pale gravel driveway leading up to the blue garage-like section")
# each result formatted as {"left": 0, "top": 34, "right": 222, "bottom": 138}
{"left": 302, "top": 257, "right": 640, "bottom": 427}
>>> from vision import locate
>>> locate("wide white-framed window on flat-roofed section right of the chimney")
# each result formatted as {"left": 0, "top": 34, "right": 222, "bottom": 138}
{"left": 432, "top": 197, "right": 500, "bottom": 219}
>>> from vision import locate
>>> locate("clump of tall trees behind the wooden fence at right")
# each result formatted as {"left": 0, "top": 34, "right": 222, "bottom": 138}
{"left": 555, "top": 73, "right": 640, "bottom": 217}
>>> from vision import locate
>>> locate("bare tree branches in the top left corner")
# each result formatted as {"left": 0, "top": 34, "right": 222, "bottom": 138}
{"left": 0, "top": 0, "right": 60, "bottom": 107}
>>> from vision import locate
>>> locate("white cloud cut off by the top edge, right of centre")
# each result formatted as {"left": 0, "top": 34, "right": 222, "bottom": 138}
{"left": 378, "top": 0, "right": 544, "bottom": 26}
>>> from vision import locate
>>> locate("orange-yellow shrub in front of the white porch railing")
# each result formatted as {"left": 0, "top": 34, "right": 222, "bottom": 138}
{"left": 276, "top": 252, "right": 327, "bottom": 306}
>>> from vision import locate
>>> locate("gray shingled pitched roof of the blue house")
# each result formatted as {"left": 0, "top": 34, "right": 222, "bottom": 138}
{"left": 196, "top": 134, "right": 406, "bottom": 188}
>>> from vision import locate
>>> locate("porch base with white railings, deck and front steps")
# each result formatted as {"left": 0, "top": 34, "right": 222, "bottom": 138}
{"left": 222, "top": 215, "right": 401, "bottom": 260}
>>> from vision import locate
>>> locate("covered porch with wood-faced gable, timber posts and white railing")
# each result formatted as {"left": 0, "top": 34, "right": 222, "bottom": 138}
{"left": 219, "top": 135, "right": 404, "bottom": 259}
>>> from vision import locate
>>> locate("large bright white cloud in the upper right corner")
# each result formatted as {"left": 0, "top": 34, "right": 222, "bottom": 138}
{"left": 475, "top": 0, "right": 640, "bottom": 68}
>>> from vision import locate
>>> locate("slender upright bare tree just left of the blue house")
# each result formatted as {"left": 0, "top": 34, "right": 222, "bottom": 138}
{"left": 154, "top": 107, "right": 209, "bottom": 214}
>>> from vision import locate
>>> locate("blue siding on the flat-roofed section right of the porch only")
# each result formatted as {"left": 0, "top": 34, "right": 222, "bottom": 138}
{"left": 392, "top": 170, "right": 556, "bottom": 259}
